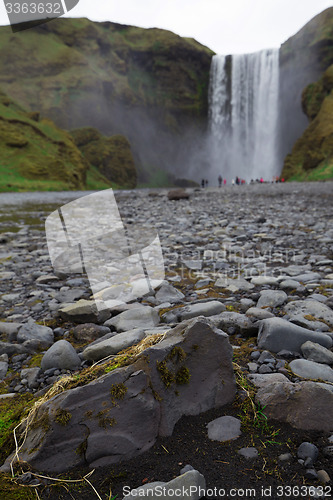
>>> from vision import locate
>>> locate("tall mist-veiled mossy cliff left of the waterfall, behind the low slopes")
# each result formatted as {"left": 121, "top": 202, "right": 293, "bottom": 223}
{"left": 0, "top": 18, "right": 213, "bottom": 181}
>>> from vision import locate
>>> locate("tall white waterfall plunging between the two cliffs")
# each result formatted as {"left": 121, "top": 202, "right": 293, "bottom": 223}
{"left": 209, "top": 49, "right": 281, "bottom": 182}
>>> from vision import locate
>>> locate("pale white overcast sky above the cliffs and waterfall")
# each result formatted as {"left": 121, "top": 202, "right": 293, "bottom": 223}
{"left": 0, "top": 0, "right": 332, "bottom": 54}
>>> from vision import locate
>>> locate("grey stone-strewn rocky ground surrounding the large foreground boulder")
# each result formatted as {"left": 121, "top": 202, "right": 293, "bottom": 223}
{"left": 0, "top": 183, "right": 333, "bottom": 499}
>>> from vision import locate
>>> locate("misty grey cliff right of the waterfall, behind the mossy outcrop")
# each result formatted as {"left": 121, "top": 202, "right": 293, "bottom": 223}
{"left": 280, "top": 8, "right": 333, "bottom": 172}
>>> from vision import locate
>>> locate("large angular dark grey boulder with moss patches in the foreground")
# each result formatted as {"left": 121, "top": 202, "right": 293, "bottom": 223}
{"left": 3, "top": 317, "right": 236, "bottom": 472}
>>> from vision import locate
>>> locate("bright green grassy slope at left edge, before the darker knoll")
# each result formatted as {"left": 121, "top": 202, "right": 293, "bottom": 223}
{"left": 0, "top": 93, "right": 88, "bottom": 191}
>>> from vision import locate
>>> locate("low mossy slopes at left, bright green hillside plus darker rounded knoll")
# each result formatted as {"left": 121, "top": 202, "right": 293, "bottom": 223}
{"left": 0, "top": 91, "right": 137, "bottom": 191}
